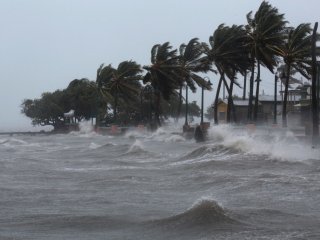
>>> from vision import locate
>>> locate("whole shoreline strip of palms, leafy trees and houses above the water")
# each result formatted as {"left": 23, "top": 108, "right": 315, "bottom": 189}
{"left": 21, "top": 1, "right": 320, "bottom": 143}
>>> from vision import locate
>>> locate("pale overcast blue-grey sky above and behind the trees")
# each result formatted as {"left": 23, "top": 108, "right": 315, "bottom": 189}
{"left": 0, "top": 0, "right": 320, "bottom": 131}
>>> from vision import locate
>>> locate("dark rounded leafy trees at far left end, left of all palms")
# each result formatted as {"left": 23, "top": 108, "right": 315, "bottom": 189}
{"left": 21, "top": 79, "right": 97, "bottom": 130}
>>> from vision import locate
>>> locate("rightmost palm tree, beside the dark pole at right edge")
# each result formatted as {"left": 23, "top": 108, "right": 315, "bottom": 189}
{"left": 276, "top": 23, "right": 318, "bottom": 127}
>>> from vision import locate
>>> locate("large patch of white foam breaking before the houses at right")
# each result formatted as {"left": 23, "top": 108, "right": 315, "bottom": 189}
{"left": 209, "top": 125, "right": 320, "bottom": 161}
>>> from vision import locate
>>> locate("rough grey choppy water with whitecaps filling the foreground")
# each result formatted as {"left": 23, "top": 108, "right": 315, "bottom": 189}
{"left": 0, "top": 123, "right": 320, "bottom": 240}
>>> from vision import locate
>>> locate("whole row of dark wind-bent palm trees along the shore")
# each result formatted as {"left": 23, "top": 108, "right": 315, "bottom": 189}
{"left": 92, "top": 1, "right": 319, "bottom": 131}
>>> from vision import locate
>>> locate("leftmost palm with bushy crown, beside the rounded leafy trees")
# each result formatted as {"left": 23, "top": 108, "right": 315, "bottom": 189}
{"left": 96, "top": 61, "right": 142, "bottom": 122}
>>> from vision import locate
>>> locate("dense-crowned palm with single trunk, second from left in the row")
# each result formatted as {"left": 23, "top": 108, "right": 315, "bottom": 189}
{"left": 143, "top": 42, "right": 182, "bottom": 126}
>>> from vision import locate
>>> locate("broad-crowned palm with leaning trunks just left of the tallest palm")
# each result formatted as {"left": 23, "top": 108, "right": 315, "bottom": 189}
{"left": 204, "top": 24, "right": 250, "bottom": 124}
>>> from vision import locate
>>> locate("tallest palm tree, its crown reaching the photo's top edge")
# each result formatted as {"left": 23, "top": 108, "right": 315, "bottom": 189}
{"left": 246, "top": 1, "right": 286, "bottom": 121}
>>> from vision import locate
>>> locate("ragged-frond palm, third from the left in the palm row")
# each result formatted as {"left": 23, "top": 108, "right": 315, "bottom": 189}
{"left": 177, "top": 38, "right": 213, "bottom": 124}
